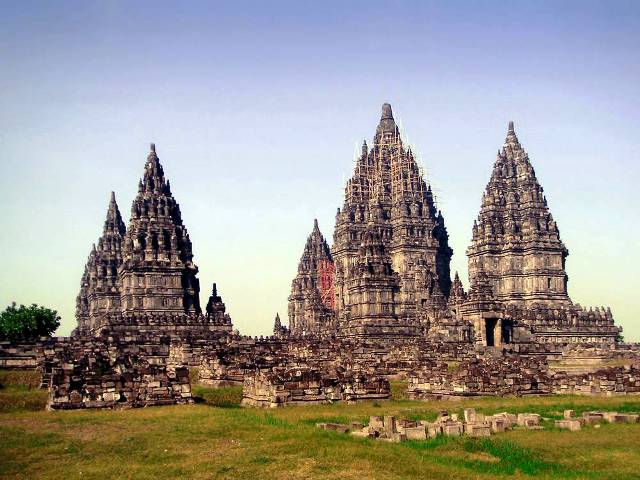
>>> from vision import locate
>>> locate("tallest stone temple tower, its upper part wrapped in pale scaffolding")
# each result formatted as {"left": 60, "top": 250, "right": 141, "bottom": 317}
{"left": 331, "top": 104, "right": 453, "bottom": 333}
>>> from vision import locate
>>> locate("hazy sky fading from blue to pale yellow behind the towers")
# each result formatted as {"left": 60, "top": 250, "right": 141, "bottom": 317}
{"left": 0, "top": 1, "right": 640, "bottom": 341}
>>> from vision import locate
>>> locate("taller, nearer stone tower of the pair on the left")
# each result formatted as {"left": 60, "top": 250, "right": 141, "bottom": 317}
{"left": 119, "top": 144, "right": 200, "bottom": 314}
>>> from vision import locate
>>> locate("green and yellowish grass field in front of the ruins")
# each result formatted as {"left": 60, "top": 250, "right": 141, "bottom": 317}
{"left": 0, "top": 372, "right": 640, "bottom": 480}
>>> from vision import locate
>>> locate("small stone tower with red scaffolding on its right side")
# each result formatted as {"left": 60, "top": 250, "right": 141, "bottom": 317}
{"left": 286, "top": 220, "right": 335, "bottom": 336}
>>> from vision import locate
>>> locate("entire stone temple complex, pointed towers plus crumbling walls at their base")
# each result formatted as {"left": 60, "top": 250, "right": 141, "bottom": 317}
{"left": 7, "top": 109, "right": 640, "bottom": 408}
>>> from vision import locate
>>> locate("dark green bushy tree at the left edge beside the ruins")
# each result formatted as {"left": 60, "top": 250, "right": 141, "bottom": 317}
{"left": 0, "top": 302, "right": 60, "bottom": 342}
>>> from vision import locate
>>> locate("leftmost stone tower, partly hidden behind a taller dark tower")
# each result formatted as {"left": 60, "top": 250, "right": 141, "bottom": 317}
{"left": 76, "top": 192, "right": 126, "bottom": 331}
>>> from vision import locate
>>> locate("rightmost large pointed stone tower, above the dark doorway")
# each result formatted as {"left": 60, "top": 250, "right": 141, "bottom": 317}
{"left": 467, "top": 122, "right": 571, "bottom": 307}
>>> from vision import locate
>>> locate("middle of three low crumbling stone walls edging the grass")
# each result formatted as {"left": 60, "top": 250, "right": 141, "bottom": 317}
{"left": 242, "top": 367, "right": 391, "bottom": 407}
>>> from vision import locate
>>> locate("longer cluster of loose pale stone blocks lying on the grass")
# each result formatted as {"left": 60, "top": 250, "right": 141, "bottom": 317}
{"left": 316, "top": 408, "right": 542, "bottom": 442}
